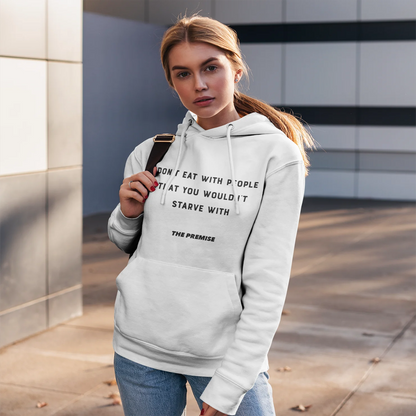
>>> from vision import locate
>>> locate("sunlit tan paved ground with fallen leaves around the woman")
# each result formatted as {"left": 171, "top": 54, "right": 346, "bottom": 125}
{"left": 0, "top": 198, "right": 416, "bottom": 416}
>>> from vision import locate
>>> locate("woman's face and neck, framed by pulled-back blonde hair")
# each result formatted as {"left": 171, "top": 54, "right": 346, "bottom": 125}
{"left": 169, "top": 42, "right": 242, "bottom": 130}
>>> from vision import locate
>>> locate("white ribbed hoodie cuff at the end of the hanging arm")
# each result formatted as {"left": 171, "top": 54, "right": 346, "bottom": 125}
{"left": 200, "top": 373, "right": 247, "bottom": 416}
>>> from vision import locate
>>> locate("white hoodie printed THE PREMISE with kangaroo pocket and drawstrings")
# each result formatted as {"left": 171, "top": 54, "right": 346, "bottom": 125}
{"left": 108, "top": 111, "right": 305, "bottom": 415}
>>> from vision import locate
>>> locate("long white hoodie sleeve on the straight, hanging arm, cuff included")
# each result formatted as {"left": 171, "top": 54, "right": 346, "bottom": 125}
{"left": 201, "top": 160, "right": 305, "bottom": 415}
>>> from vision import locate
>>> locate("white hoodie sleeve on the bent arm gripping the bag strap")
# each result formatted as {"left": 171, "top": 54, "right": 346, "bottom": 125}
{"left": 108, "top": 151, "right": 144, "bottom": 251}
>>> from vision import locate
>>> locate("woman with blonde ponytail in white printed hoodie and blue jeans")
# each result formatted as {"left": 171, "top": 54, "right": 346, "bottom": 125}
{"left": 109, "top": 15, "right": 313, "bottom": 416}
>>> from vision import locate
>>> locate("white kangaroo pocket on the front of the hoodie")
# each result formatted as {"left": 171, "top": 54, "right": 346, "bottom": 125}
{"left": 115, "top": 256, "right": 242, "bottom": 358}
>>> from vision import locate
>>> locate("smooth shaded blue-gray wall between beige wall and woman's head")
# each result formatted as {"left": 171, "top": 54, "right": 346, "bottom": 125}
{"left": 83, "top": 13, "right": 186, "bottom": 215}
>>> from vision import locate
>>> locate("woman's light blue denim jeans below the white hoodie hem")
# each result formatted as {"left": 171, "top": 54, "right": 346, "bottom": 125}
{"left": 114, "top": 352, "right": 276, "bottom": 416}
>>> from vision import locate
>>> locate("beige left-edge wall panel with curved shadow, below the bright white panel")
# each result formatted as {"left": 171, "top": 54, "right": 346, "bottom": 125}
{"left": 0, "top": 173, "right": 46, "bottom": 312}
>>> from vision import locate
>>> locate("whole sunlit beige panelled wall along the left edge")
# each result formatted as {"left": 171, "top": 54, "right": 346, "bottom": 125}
{"left": 0, "top": 0, "right": 83, "bottom": 347}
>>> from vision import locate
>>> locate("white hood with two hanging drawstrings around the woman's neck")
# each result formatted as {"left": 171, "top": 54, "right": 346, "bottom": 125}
{"left": 160, "top": 110, "right": 280, "bottom": 215}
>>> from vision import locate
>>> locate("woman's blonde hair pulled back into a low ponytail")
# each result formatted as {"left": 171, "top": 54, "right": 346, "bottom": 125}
{"left": 160, "top": 14, "right": 315, "bottom": 175}
